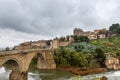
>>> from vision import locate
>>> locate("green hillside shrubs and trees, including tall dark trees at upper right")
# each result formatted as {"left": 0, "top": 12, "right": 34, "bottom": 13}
{"left": 54, "top": 23, "right": 120, "bottom": 69}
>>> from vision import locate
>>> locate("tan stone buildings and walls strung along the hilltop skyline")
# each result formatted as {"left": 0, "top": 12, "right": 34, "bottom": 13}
{"left": 13, "top": 28, "right": 116, "bottom": 50}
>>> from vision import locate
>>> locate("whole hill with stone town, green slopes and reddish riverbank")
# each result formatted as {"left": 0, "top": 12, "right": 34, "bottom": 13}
{"left": 1, "top": 24, "right": 120, "bottom": 78}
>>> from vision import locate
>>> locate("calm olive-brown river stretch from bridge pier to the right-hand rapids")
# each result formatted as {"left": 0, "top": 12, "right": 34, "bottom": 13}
{"left": 29, "top": 70, "right": 74, "bottom": 80}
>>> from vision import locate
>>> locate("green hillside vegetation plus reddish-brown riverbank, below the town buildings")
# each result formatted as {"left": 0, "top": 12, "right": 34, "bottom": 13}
{"left": 54, "top": 36, "right": 120, "bottom": 75}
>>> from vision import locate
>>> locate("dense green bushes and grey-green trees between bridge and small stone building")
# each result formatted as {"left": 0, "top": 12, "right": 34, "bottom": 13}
{"left": 54, "top": 36, "right": 105, "bottom": 70}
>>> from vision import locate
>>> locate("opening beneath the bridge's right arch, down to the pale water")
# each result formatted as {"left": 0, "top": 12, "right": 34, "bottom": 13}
{"left": 28, "top": 53, "right": 46, "bottom": 80}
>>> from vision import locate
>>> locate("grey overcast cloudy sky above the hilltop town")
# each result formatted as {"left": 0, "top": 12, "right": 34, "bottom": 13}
{"left": 0, "top": 0, "right": 120, "bottom": 48}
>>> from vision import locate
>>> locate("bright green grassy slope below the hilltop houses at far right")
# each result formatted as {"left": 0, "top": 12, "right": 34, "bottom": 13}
{"left": 91, "top": 36, "right": 120, "bottom": 57}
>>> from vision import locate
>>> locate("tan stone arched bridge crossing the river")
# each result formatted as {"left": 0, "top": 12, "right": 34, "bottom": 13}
{"left": 0, "top": 49, "right": 56, "bottom": 80}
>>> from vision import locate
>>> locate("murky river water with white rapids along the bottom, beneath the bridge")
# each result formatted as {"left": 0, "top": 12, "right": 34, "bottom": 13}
{"left": 0, "top": 67, "right": 120, "bottom": 80}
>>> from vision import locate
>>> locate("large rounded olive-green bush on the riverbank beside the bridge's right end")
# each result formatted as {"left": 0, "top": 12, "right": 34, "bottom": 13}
{"left": 54, "top": 48, "right": 88, "bottom": 67}
